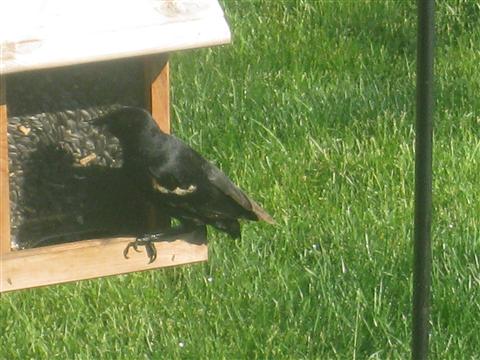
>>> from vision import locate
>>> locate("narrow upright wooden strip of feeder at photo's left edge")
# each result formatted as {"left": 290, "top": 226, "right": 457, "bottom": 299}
{"left": 0, "top": 75, "right": 11, "bottom": 256}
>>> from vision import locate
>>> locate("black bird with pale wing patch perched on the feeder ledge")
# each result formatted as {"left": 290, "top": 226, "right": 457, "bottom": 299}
{"left": 95, "top": 107, "right": 274, "bottom": 262}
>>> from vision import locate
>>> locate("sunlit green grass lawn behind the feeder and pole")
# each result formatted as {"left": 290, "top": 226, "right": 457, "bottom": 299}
{"left": 0, "top": 0, "right": 480, "bottom": 359}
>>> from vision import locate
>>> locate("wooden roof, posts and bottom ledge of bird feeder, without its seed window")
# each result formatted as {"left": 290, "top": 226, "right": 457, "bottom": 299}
{"left": 0, "top": 0, "right": 230, "bottom": 292}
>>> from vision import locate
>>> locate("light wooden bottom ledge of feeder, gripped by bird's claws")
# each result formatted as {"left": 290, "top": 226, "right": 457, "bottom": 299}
{"left": 0, "top": 233, "right": 208, "bottom": 292}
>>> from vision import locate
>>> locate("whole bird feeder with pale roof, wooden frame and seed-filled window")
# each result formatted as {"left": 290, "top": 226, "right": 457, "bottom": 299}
{"left": 0, "top": 0, "right": 230, "bottom": 292}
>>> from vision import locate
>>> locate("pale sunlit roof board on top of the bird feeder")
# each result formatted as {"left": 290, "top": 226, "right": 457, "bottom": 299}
{"left": 0, "top": 0, "right": 230, "bottom": 74}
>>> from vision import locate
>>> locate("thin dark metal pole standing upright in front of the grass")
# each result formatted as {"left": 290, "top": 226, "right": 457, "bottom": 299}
{"left": 412, "top": 0, "right": 435, "bottom": 360}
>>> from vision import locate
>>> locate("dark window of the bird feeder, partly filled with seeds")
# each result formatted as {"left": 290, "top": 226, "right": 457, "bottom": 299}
{"left": 7, "top": 60, "right": 151, "bottom": 249}
